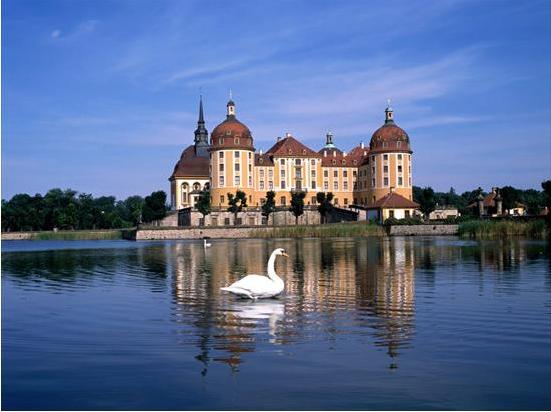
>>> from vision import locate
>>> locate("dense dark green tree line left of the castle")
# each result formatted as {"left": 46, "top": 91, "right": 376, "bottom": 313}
{"left": 2, "top": 188, "right": 168, "bottom": 231}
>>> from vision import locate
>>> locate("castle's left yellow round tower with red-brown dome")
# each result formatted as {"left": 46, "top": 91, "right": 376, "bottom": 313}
{"left": 209, "top": 95, "right": 254, "bottom": 207}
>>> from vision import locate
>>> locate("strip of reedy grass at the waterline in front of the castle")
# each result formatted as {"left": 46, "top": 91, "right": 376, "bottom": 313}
{"left": 251, "top": 222, "right": 385, "bottom": 238}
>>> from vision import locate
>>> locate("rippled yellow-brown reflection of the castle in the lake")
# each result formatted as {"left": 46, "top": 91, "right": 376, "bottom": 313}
{"left": 170, "top": 238, "right": 415, "bottom": 373}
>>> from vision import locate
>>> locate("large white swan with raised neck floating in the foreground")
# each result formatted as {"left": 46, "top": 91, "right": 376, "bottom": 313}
{"left": 220, "top": 248, "right": 288, "bottom": 299}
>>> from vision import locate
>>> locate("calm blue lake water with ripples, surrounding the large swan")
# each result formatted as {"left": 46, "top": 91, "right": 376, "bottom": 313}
{"left": 2, "top": 238, "right": 551, "bottom": 409}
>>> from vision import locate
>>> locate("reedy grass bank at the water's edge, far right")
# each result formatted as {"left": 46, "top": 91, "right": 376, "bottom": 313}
{"left": 458, "top": 219, "right": 548, "bottom": 239}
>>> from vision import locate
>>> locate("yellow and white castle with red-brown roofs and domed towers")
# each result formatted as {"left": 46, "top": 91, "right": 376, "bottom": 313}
{"left": 169, "top": 98, "right": 417, "bottom": 222}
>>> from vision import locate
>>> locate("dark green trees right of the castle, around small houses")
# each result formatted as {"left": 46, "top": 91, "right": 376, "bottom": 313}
{"left": 413, "top": 180, "right": 551, "bottom": 216}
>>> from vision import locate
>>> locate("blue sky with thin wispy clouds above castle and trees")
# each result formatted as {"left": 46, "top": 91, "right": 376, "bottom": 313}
{"left": 2, "top": 0, "right": 551, "bottom": 198}
